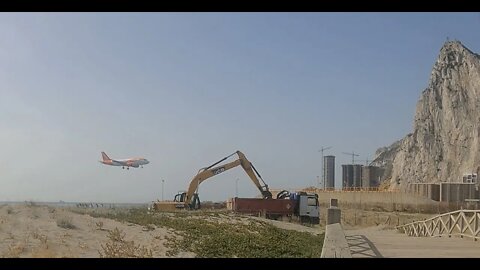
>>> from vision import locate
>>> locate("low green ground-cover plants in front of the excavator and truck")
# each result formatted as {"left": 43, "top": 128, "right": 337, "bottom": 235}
{"left": 88, "top": 209, "right": 324, "bottom": 258}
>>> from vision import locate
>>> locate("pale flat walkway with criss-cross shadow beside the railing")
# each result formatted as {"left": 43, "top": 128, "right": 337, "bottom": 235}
{"left": 345, "top": 226, "right": 480, "bottom": 258}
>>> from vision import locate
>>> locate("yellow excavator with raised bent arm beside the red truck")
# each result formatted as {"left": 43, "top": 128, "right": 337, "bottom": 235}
{"left": 153, "top": 151, "right": 272, "bottom": 211}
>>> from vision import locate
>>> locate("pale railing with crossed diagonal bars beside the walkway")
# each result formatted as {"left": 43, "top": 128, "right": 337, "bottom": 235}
{"left": 396, "top": 210, "right": 480, "bottom": 241}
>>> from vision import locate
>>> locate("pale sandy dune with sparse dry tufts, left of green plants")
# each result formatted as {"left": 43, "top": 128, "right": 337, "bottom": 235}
{"left": 0, "top": 205, "right": 175, "bottom": 258}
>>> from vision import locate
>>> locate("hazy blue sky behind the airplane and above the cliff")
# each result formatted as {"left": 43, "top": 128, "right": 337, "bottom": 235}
{"left": 0, "top": 13, "right": 480, "bottom": 202}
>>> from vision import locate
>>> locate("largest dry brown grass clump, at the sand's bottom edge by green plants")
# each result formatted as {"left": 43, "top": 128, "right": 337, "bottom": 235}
{"left": 99, "top": 228, "right": 153, "bottom": 258}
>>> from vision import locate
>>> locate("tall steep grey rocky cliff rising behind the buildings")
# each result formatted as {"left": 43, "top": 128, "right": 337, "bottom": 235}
{"left": 374, "top": 41, "right": 480, "bottom": 188}
